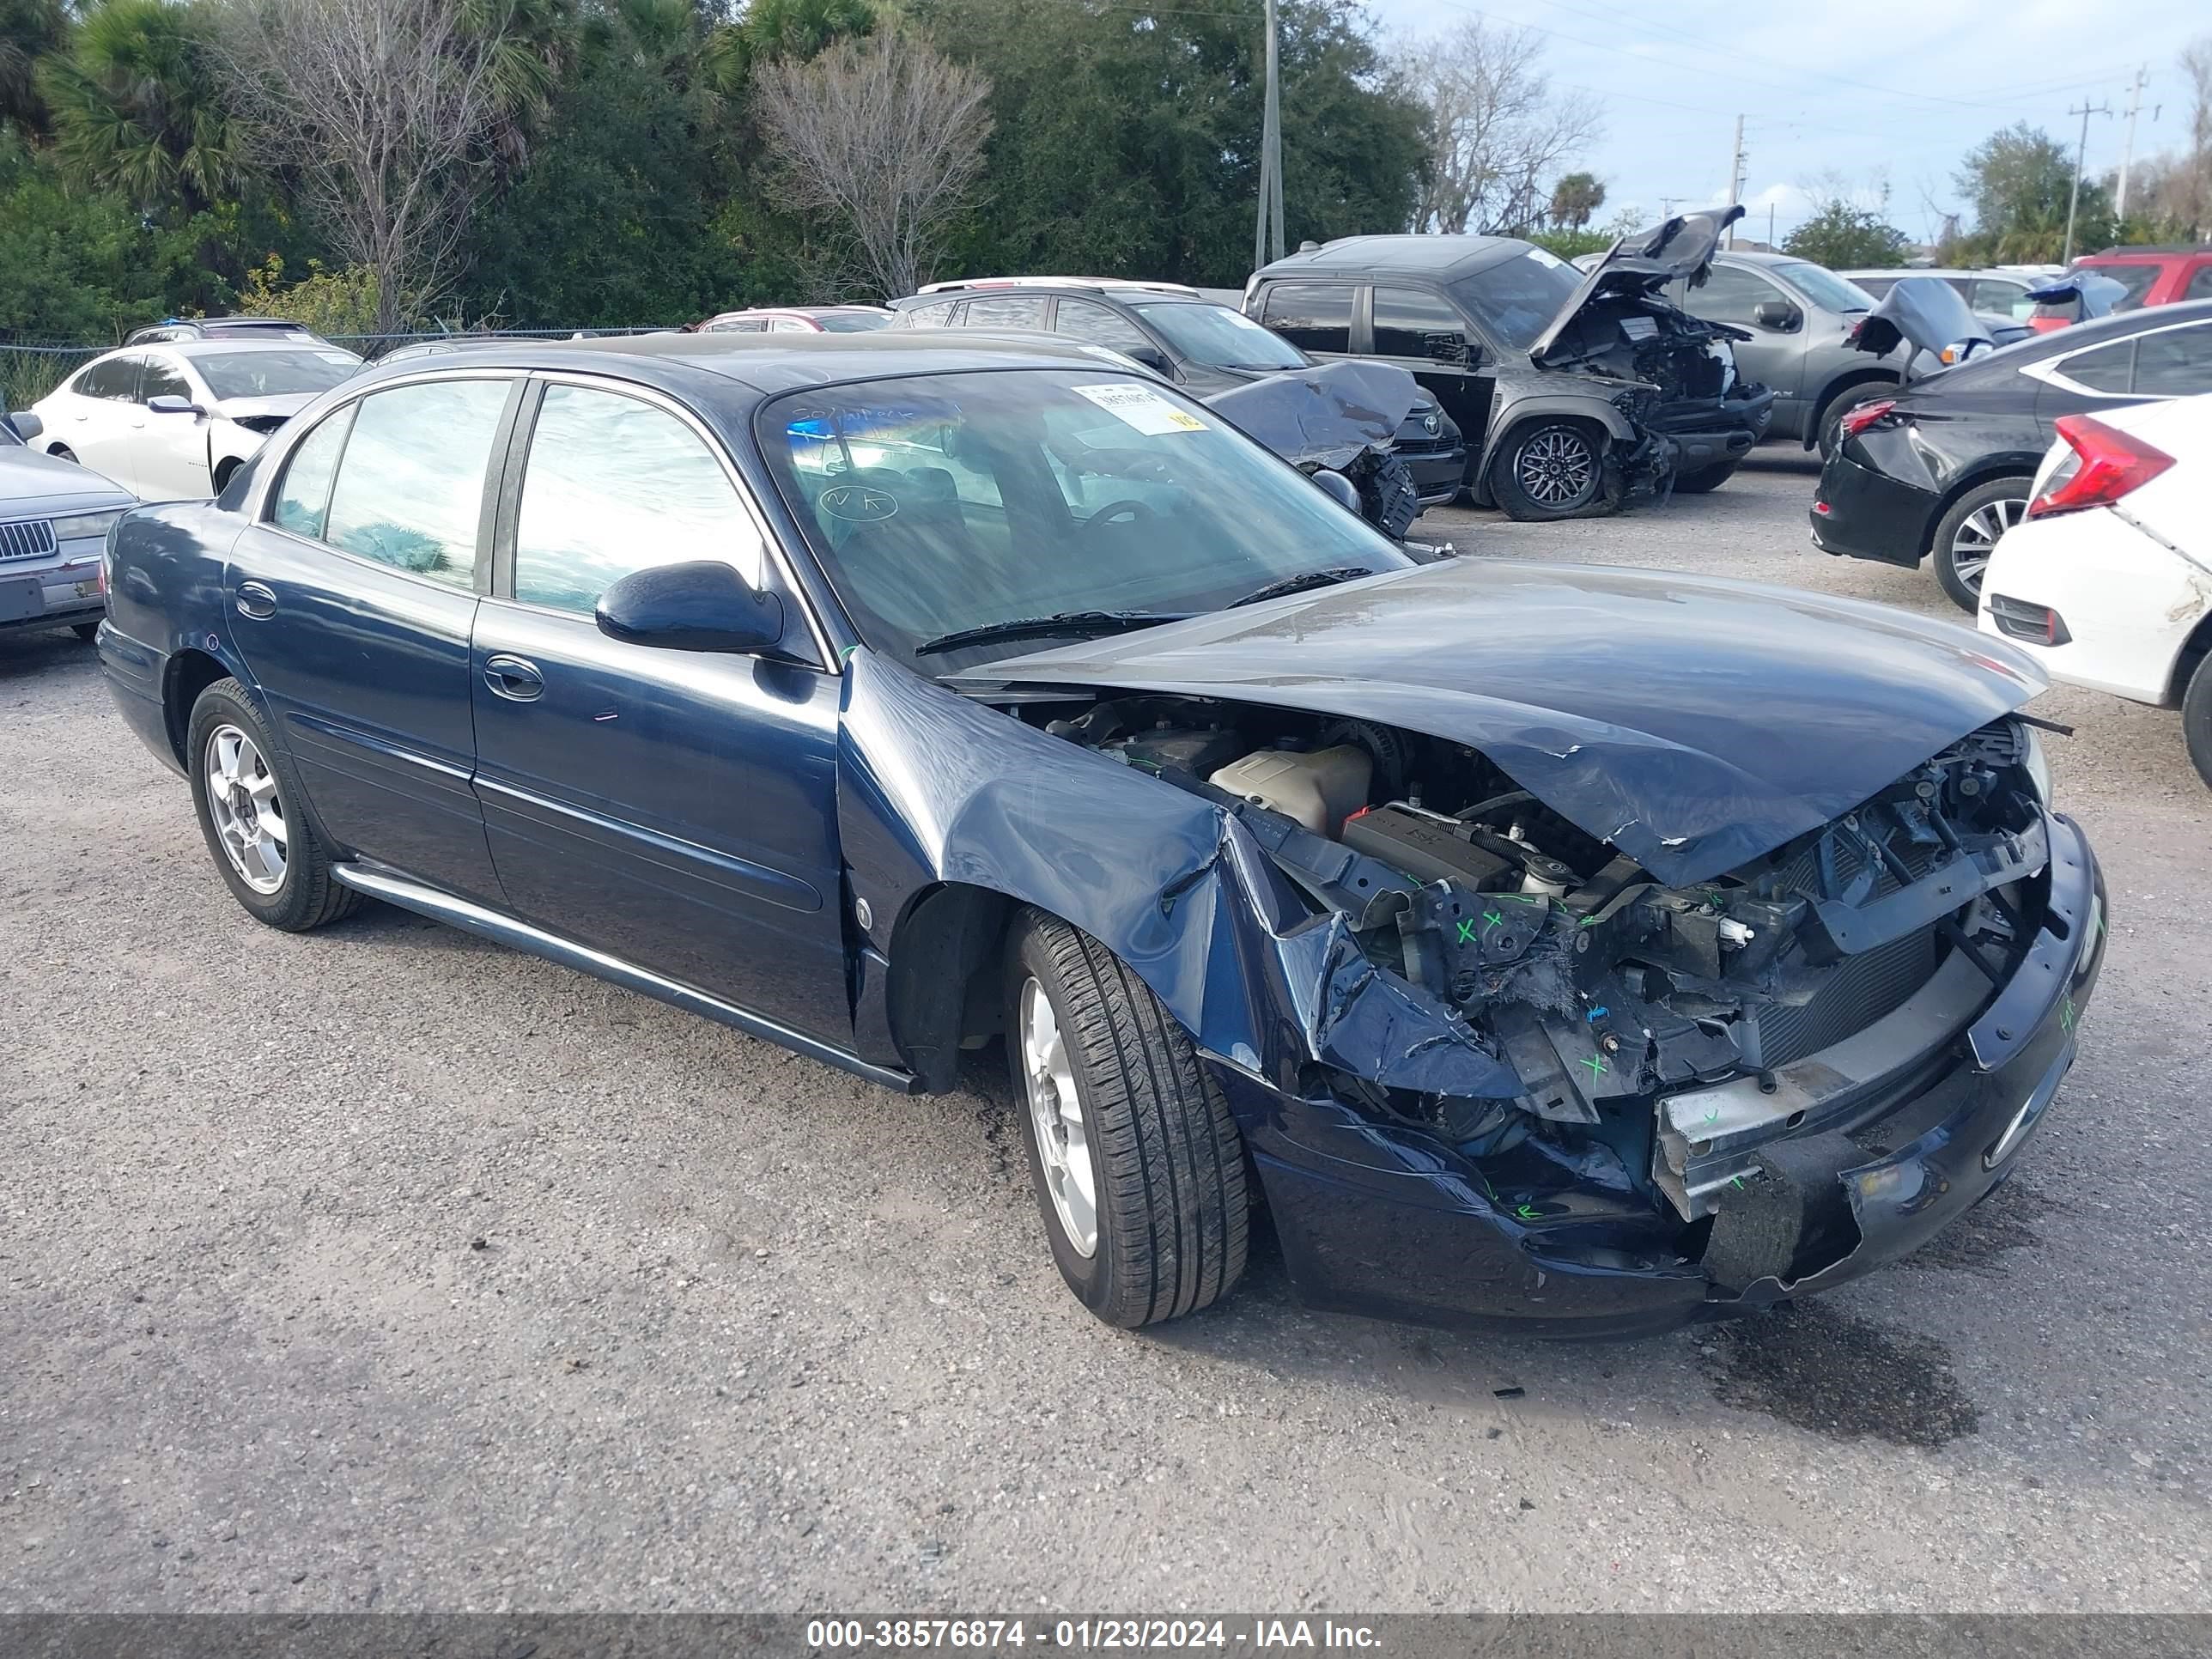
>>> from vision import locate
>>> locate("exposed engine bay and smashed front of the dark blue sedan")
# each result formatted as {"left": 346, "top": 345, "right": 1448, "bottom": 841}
{"left": 1029, "top": 695, "right": 2046, "bottom": 1228}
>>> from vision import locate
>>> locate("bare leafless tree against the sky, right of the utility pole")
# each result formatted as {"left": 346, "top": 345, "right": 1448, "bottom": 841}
{"left": 1391, "top": 18, "right": 1604, "bottom": 234}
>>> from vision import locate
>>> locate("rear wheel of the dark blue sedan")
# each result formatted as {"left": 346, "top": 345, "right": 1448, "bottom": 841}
{"left": 184, "top": 679, "right": 361, "bottom": 933}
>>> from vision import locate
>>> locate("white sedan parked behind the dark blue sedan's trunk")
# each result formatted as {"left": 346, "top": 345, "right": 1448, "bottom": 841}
{"left": 31, "top": 341, "right": 361, "bottom": 502}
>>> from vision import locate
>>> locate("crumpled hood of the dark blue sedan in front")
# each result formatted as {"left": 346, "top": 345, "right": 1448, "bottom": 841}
{"left": 951, "top": 560, "right": 2048, "bottom": 884}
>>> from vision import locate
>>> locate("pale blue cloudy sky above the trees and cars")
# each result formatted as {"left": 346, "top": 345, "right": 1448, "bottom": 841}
{"left": 1370, "top": 0, "right": 2212, "bottom": 241}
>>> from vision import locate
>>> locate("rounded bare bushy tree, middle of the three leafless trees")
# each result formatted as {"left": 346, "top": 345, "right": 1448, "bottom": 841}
{"left": 752, "top": 28, "right": 991, "bottom": 299}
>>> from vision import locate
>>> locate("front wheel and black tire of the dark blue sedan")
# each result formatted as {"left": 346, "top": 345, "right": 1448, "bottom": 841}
{"left": 1006, "top": 909, "right": 1249, "bottom": 1329}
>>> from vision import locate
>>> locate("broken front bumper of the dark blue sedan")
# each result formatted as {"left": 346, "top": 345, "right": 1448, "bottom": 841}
{"left": 1214, "top": 817, "right": 2104, "bottom": 1336}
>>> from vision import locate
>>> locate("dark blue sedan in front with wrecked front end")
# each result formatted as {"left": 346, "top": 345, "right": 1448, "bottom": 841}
{"left": 101, "top": 334, "right": 2104, "bottom": 1336}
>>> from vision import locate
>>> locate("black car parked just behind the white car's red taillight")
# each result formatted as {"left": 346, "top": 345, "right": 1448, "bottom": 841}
{"left": 1812, "top": 301, "right": 2212, "bottom": 611}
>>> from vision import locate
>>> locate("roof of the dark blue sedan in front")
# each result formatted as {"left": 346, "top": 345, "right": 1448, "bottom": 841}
{"left": 347, "top": 330, "right": 1133, "bottom": 400}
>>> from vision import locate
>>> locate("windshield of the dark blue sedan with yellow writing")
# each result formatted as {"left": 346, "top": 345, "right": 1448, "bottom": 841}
{"left": 754, "top": 368, "right": 1411, "bottom": 675}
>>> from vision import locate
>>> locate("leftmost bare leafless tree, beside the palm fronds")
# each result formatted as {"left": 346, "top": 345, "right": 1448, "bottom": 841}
{"left": 216, "top": 0, "right": 504, "bottom": 330}
